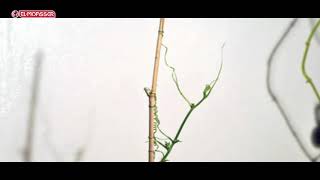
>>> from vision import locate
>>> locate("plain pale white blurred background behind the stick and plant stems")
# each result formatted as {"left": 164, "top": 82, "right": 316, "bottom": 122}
{"left": 0, "top": 19, "right": 320, "bottom": 161}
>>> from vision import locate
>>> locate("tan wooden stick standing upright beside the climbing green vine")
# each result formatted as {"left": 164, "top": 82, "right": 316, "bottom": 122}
{"left": 149, "top": 18, "right": 164, "bottom": 162}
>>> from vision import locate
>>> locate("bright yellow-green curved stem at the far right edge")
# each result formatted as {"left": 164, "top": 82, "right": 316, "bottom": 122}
{"left": 301, "top": 20, "right": 320, "bottom": 102}
